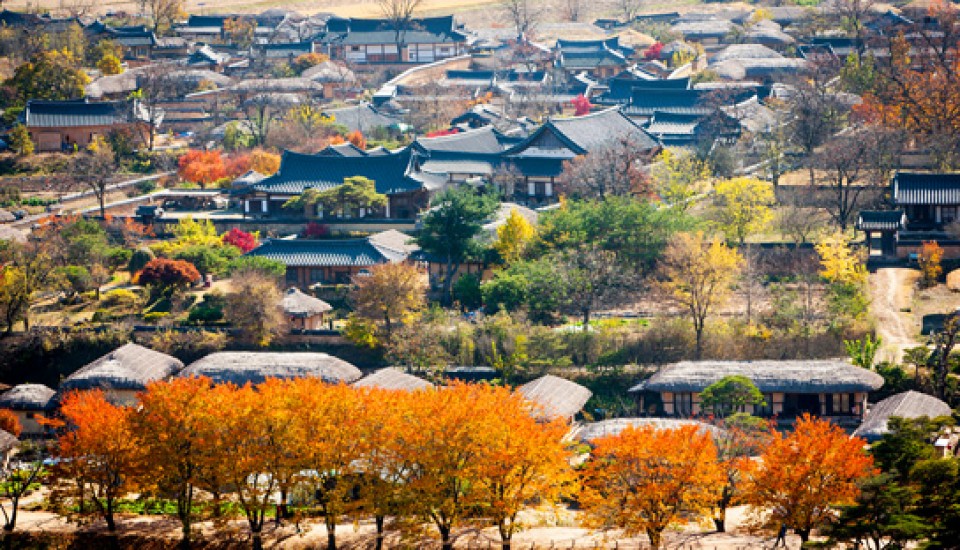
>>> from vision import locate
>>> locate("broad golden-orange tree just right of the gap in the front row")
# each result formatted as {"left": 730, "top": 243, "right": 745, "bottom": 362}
{"left": 580, "top": 426, "right": 724, "bottom": 548}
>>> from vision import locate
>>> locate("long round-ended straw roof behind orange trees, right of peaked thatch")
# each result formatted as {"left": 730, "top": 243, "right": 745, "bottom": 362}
{"left": 180, "top": 351, "right": 363, "bottom": 386}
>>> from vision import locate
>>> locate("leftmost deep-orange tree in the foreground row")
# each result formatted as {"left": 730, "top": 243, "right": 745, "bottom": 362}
{"left": 57, "top": 390, "right": 143, "bottom": 531}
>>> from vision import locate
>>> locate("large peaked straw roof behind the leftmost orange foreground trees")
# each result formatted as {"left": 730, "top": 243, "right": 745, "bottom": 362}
{"left": 60, "top": 342, "right": 183, "bottom": 393}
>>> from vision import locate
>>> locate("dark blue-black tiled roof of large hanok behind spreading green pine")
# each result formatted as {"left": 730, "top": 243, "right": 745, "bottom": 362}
{"left": 253, "top": 150, "right": 422, "bottom": 195}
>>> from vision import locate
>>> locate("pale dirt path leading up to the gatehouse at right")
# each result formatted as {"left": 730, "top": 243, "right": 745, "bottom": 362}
{"left": 870, "top": 268, "right": 921, "bottom": 362}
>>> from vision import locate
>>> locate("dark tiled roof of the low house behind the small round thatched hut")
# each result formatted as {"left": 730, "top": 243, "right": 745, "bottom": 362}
{"left": 247, "top": 239, "right": 393, "bottom": 267}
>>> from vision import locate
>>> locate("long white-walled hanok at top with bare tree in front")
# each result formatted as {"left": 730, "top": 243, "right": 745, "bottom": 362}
{"left": 314, "top": 15, "right": 468, "bottom": 63}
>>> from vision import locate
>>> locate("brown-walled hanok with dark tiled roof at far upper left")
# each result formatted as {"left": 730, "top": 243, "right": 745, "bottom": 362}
{"left": 22, "top": 100, "right": 150, "bottom": 152}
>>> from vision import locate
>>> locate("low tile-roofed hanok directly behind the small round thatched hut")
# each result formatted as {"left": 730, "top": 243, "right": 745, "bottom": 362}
{"left": 247, "top": 232, "right": 410, "bottom": 288}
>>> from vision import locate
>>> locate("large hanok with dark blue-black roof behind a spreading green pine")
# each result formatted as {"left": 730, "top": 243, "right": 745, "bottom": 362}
{"left": 236, "top": 149, "right": 445, "bottom": 220}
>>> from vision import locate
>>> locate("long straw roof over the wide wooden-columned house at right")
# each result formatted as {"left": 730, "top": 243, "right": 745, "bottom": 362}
{"left": 630, "top": 359, "right": 883, "bottom": 393}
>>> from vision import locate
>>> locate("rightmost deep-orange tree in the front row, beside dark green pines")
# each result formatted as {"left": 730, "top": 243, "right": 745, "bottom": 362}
{"left": 743, "top": 414, "right": 876, "bottom": 542}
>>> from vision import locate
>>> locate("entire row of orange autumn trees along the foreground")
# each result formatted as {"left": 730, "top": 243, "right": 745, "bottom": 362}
{"left": 48, "top": 384, "right": 873, "bottom": 549}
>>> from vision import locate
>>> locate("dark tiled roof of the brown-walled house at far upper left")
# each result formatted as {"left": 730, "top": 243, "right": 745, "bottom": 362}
{"left": 24, "top": 100, "right": 139, "bottom": 128}
